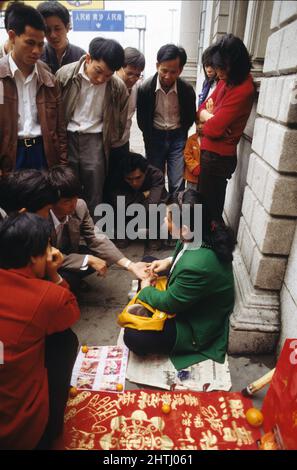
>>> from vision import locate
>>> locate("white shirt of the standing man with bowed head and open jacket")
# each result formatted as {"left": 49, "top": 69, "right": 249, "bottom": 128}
{"left": 67, "top": 61, "right": 106, "bottom": 134}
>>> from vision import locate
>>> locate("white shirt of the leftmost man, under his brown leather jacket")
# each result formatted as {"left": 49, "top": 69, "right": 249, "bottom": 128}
{"left": 8, "top": 53, "right": 41, "bottom": 139}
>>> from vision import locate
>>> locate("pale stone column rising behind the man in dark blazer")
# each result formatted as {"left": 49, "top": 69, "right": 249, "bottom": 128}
{"left": 179, "top": 0, "right": 201, "bottom": 88}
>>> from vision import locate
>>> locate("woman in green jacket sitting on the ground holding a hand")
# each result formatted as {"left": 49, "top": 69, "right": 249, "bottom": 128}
{"left": 124, "top": 189, "right": 234, "bottom": 369}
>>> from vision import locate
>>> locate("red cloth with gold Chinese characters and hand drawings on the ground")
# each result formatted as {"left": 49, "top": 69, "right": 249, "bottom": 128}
{"left": 55, "top": 390, "right": 260, "bottom": 450}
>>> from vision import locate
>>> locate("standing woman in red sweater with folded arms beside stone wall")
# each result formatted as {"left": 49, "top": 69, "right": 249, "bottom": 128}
{"left": 197, "top": 34, "right": 255, "bottom": 222}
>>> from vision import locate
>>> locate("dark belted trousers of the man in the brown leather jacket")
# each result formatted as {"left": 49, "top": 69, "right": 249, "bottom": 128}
{"left": 15, "top": 137, "right": 48, "bottom": 170}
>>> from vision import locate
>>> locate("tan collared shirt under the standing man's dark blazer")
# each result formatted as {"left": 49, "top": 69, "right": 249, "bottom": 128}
{"left": 153, "top": 76, "right": 180, "bottom": 131}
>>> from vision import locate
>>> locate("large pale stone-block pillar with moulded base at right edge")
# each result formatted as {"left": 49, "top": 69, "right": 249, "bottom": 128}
{"left": 229, "top": 2, "right": 297, "bottom": 353}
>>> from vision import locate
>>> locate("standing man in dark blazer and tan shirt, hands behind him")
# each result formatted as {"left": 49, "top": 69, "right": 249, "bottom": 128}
{"left": 137, "top": 44, "right": 196, "bottom": 193}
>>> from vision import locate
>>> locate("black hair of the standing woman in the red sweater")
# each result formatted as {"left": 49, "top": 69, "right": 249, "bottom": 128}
{"left": 211, "top": 34, "right": 251, "bottom": 85}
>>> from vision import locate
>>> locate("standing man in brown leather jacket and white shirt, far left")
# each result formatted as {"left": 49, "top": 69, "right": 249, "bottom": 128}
{"left": 0, "top": 5, "right": 67, "bottom": 169}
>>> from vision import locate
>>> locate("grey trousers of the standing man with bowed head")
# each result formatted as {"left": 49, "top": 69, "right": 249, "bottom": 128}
{"left": 67, "top": 132, "right": 106, "bottom": 217}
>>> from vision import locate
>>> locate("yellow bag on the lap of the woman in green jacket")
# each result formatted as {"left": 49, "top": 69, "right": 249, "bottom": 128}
{"left": 118, "top": 277, "right": 175, "bottom": 331}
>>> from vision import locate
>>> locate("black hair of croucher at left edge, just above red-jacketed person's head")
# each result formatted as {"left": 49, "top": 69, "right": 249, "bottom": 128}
{"left": 0, "top": 169, "right": 59, "bottom": 214}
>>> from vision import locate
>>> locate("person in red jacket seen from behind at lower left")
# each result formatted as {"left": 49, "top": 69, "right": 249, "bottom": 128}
{"left": 0, "top": 213, "right": 80, "bottom": 450}
